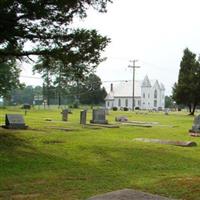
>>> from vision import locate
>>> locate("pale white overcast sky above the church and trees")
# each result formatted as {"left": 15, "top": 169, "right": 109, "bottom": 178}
{"left": 19, "top": 0, "right": 200, "bottom": 94}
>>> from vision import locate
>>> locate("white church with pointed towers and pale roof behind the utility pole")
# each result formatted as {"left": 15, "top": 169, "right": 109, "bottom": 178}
{"left": 105, "top": 76, "right": 165, "bottom": 110}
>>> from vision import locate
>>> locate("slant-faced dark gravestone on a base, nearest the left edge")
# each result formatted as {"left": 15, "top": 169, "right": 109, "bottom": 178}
{"left": 2, "top": 114, "right": 28, "bottom": 129}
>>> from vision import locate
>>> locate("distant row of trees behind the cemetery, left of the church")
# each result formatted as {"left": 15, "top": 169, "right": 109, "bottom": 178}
{"left": 4, "top": 74, "right": 107, "bottom": 107}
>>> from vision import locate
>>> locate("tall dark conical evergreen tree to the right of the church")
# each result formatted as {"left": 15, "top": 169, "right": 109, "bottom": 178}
{"left": 173, "top": 49, "right": 200, "bottom": 115}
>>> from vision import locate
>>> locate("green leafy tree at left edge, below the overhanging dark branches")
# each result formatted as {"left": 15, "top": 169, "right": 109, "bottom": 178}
{"left": 0, "top": 59, "right": 23, "bottom": 98}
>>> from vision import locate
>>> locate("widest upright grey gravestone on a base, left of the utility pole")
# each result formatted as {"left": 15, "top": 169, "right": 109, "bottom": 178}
{"left": 90, "top": 109, "right": 108, "bottom": 124}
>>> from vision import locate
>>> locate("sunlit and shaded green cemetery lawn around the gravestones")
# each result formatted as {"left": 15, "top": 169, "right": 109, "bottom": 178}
{"left": 0, "top": 108, "right": 200, "bottom": 200}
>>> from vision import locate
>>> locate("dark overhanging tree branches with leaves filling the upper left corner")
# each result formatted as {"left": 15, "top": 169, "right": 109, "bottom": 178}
{"left": 0, "top": 0, "right": 111, "bottom": 68}
